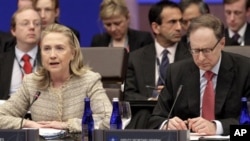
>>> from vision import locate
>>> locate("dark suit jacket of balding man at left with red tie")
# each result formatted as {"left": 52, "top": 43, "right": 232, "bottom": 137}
{"left": 0, "top": 38, "right": 41, "bottom": 99}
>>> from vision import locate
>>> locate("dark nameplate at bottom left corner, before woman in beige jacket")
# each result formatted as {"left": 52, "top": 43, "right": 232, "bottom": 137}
{"left": 0, "top": 129, "right": 40, "bottom": 141}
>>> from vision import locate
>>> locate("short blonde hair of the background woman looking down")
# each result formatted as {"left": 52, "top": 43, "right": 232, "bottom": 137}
{"left": 100, "top": 0, "right": 129, "bottom": 20}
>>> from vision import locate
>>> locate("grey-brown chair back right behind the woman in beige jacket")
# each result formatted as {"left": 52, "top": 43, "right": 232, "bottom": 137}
{"left": 82, "top": 47, "right": 128, "bottom": 101}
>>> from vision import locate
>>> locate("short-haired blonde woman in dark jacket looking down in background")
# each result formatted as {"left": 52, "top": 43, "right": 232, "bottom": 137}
{"left": 90, "top": 0, "right": 154, "bottom": 52}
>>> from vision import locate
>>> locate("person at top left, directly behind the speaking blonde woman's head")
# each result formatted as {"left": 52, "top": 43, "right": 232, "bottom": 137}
{"left": 33, "top": 0, "right": 80, "bottom": 41}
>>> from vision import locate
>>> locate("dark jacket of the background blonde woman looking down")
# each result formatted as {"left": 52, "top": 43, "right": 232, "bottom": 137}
{"left": 91, "top": 29, "right": 154, "bottom": 52}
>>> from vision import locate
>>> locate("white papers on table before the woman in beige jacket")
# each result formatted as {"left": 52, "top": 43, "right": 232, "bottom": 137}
{"left": 39, "top": 128, "right": 66, "bottom": 140}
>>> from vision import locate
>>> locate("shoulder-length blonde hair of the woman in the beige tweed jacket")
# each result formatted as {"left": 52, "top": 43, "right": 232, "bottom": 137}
{"left": 35, "top": 23, "right": 90, "bottom": 89}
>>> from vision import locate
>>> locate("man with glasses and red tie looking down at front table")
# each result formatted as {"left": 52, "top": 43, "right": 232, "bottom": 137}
{"left": 148, "top": 14, "right": 250, "bottom": 135}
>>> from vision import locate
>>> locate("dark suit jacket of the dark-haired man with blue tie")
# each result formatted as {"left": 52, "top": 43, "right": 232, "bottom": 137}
{"left": 124, "top": 42, "right": 191, "bottom": 100}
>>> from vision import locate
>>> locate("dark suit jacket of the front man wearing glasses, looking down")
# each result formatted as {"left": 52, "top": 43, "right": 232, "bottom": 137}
{"left": 149, "top": 52, "right": 250, "bottom": 135}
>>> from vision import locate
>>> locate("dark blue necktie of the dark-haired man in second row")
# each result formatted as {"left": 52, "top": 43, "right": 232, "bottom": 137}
{"left": 158, "top": 49, "right": 169, "bottom": 85}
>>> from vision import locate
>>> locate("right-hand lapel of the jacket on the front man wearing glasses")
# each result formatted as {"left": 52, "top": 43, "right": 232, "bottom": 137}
{"left": 215, "top": 53, "right": 235, "bottom": 113}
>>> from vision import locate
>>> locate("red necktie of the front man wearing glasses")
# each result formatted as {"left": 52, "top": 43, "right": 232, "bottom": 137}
{"left": 202, "top": 71, "right": 215, "bottom": 120}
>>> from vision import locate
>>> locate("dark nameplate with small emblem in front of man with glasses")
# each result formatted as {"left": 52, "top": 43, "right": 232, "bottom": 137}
{"left": 94, "top": 129, "right": 190, "bottom": 141}
